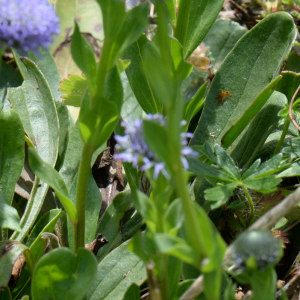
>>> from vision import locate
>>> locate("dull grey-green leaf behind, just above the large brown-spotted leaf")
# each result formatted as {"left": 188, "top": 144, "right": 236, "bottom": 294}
{"left": 203, "top": 19, "right": 248, "bottom": 70}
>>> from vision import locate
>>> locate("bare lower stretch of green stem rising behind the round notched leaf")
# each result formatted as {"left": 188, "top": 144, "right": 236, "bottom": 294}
{"left": 74, "top": 144, "right": 94, "bottom": 253}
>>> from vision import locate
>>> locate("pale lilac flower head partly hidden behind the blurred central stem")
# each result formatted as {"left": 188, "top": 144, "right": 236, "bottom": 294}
{"left": 115, "top": 114, "right": 199, "bottom": 179}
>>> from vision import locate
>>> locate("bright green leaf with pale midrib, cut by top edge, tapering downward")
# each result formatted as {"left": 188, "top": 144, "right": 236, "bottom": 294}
{"left": 175, "top": 0, "right": 224, "bottom": 59}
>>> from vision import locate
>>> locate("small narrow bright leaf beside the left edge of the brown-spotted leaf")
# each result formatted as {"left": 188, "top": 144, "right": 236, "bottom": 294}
{"left": 184, "top": 81, "right": 208, "bottom": 126}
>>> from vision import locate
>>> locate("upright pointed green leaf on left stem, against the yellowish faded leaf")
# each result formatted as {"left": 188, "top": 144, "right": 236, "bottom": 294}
{"left": 71, "top": 23, "right": 97, "bottom": 92}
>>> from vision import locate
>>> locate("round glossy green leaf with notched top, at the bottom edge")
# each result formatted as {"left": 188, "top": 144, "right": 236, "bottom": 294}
{"left": 31, "top": 248, "right": 97, "bottom": 300}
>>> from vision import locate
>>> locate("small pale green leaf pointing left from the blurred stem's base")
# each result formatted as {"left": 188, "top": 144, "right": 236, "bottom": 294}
{"left": 154, "top": 233, "right": 201, "bottom": 268}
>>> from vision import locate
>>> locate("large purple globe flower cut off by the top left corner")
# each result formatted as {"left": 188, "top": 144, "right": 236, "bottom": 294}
{"left": 0, "top": 0, "right": 59, "bottom": 52}
